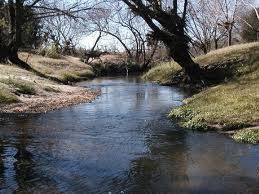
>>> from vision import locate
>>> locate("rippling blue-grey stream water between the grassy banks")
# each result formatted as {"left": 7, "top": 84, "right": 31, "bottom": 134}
{"left": 0, "top": 78, "right": 259, "bottom": 194}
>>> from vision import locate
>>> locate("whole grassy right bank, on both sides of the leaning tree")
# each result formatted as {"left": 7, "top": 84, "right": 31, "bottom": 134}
{"left": 144, "top": 43, "right": 259, "bottom": 143}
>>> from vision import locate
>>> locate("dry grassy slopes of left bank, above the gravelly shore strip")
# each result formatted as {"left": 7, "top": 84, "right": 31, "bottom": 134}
{"left": 0, "top": 53, "right": 94, "bottom": 104}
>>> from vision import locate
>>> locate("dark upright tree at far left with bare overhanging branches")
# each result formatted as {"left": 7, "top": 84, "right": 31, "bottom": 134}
{"left": 0, "top": 0, "right": 98, "bottom": 73}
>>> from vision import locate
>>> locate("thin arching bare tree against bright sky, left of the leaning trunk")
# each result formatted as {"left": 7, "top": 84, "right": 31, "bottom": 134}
{"left": 101, "top": 3, "right": 156, "bottom": 69}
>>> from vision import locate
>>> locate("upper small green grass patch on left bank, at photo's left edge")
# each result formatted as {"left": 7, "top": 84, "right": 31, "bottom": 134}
{"left": 0, "top": 79, "right": 36, "bottom": 95}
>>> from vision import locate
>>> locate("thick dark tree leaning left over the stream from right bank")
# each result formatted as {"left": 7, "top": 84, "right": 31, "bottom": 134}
{"left": 122, "top": 0, "right": 202, "bottom": 81}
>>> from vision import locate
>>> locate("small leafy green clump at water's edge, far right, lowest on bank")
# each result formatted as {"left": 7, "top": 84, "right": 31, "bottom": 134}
{"left": 232, "top": 127, "right": 259, "bottom": 144}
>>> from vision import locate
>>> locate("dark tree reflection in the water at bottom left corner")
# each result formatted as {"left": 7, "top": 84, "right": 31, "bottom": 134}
{"left": 0, "top": 115, "right": 58, "bottom": 193}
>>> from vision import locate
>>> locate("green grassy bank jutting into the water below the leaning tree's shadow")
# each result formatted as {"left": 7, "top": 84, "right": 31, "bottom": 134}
{"left": 170, "top": 79, "right": 259, "bottom": 131}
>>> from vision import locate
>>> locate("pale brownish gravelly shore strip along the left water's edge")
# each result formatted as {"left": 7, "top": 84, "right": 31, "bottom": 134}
{"left": 0, "top": 85, "right": 100, "bottom": 113}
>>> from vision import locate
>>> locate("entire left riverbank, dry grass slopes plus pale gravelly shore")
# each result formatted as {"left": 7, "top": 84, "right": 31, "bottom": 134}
{"left": 0, "top": 53, "right": 99, "bottom": 113}
